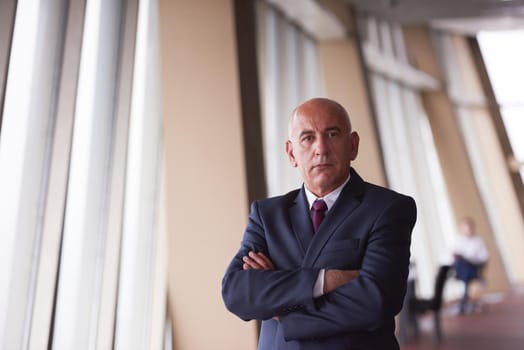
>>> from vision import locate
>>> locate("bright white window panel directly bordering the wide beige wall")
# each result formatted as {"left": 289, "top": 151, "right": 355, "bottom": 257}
{"left": 114, "top": 0, "right": 167, "bottom": 350}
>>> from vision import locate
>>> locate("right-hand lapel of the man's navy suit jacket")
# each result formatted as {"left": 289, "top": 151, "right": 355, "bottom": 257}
{"left": 303, "top": 169, "right": 364, "bottom": 266}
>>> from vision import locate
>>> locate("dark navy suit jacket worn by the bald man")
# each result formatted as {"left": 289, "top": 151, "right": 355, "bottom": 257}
{"left": 222, "top": 169, "right": 416, "bottom": 350}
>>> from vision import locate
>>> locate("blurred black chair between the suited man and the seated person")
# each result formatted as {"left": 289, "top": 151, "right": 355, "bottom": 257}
{"left": 409, "top": 265, "right": 450, "bottom": 342}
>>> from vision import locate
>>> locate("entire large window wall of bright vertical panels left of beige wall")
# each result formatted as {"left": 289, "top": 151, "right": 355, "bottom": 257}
{"left": 0, "top": 0, "right": 166, "bottom": 349}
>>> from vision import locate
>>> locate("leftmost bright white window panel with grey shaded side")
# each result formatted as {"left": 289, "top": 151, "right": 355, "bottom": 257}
{"left": 0, "top": 0, "right": 67, "bottom": 349}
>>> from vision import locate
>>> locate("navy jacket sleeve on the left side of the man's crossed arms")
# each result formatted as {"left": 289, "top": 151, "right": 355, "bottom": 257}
{"left": 222, "top": 202, "right": 320, "bottom": 321}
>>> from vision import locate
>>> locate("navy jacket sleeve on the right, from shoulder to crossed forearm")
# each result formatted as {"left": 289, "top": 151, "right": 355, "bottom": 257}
{"left": 280, "top": 196, "right": 416, "bottom": 340}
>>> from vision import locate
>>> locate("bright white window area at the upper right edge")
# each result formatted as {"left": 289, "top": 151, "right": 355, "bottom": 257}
{"left": 478, "top": 30, "right": 524, "bottom": 179}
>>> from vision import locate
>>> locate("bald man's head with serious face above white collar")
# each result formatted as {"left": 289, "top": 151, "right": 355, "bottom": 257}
{"left": 286, "top": 102, "right": 359, "bottom": 197}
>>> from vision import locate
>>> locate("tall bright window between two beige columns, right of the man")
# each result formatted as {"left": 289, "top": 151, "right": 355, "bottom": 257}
{"left": 359, "top": 17, "right": 456, "bottom": 296}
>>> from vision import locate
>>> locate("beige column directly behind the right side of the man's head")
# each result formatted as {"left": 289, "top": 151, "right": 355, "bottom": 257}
{"left": 318, "top": 38, "right": 386, "bottom": 185}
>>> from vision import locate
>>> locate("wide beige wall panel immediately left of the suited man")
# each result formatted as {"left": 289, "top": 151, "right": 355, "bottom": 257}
{"left": 160, "top": 0, "right": 256, "bottom": 350}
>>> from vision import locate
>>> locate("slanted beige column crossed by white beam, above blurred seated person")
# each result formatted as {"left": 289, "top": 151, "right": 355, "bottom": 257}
{"left": 404, "top": 27, "right": 509, "bottom": 291}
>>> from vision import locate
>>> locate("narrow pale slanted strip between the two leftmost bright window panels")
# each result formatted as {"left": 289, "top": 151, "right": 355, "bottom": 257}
{"left": 29, "top": 0, "right": 85, "bottom": 349}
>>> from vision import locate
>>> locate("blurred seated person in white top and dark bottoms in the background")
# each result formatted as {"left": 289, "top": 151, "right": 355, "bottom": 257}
{"left": 453, "top": 217, "right": 488, "bottom": 314}
